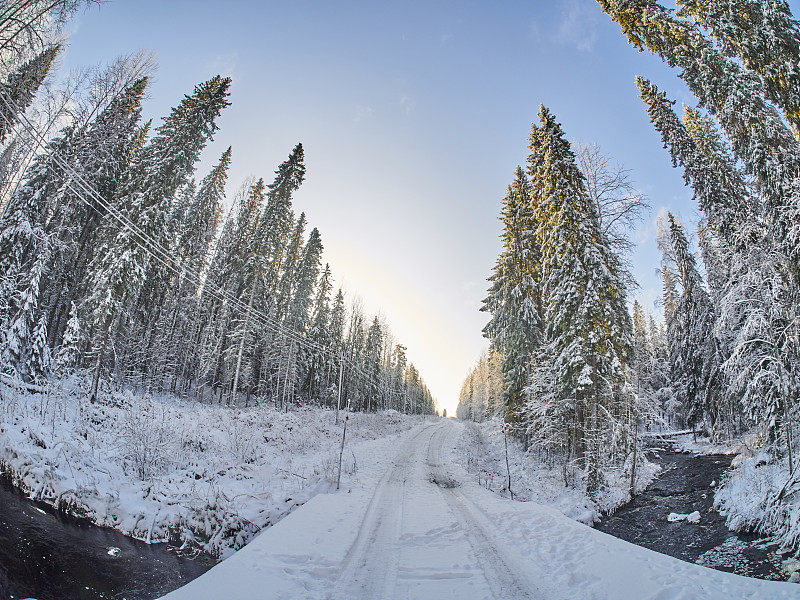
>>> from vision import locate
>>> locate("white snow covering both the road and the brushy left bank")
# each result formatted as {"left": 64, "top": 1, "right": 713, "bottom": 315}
{"left": 0, "top": 379, "right": 798, "bottom": 600}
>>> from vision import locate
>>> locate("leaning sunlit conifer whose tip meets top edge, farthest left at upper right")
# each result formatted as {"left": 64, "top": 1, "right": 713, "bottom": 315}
{"left": 598, "top": 0, "right": 800, "bottom": 271}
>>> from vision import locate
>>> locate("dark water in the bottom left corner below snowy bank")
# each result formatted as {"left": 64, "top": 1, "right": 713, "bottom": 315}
{"left": 0, "top": 482, "right": 214, "bottom": 600}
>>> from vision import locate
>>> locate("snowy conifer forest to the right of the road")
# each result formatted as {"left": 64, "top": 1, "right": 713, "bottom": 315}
{"left": 458, "top": 0, "right": 800, "bottom": 549}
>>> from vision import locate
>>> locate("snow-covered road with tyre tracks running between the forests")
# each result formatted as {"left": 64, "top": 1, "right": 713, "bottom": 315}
{"left": 159, "top": 420, "right": 800, "bottom": 600}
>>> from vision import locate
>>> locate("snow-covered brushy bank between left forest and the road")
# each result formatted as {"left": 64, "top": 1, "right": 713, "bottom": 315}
{"left": 0, "top": 376, "right": 421, "bottom": 557}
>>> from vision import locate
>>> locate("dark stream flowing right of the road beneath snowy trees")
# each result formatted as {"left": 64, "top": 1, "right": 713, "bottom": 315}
{"left": 595, "top": 450, "right": 787, "bottom": 580}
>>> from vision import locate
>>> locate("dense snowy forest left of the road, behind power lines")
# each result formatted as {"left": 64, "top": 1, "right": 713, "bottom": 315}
{"left": 0, "top": 0, "right": 435, "bottom": 414}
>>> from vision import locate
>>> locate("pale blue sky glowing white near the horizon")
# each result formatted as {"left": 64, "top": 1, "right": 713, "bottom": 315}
{"left": 56, "top": 0, "right": 798, "bottom": 414}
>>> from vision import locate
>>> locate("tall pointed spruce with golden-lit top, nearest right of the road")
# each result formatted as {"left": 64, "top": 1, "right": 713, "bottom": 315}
{"left": 528, "top": 106, "right": 631, "bottom": 498}
